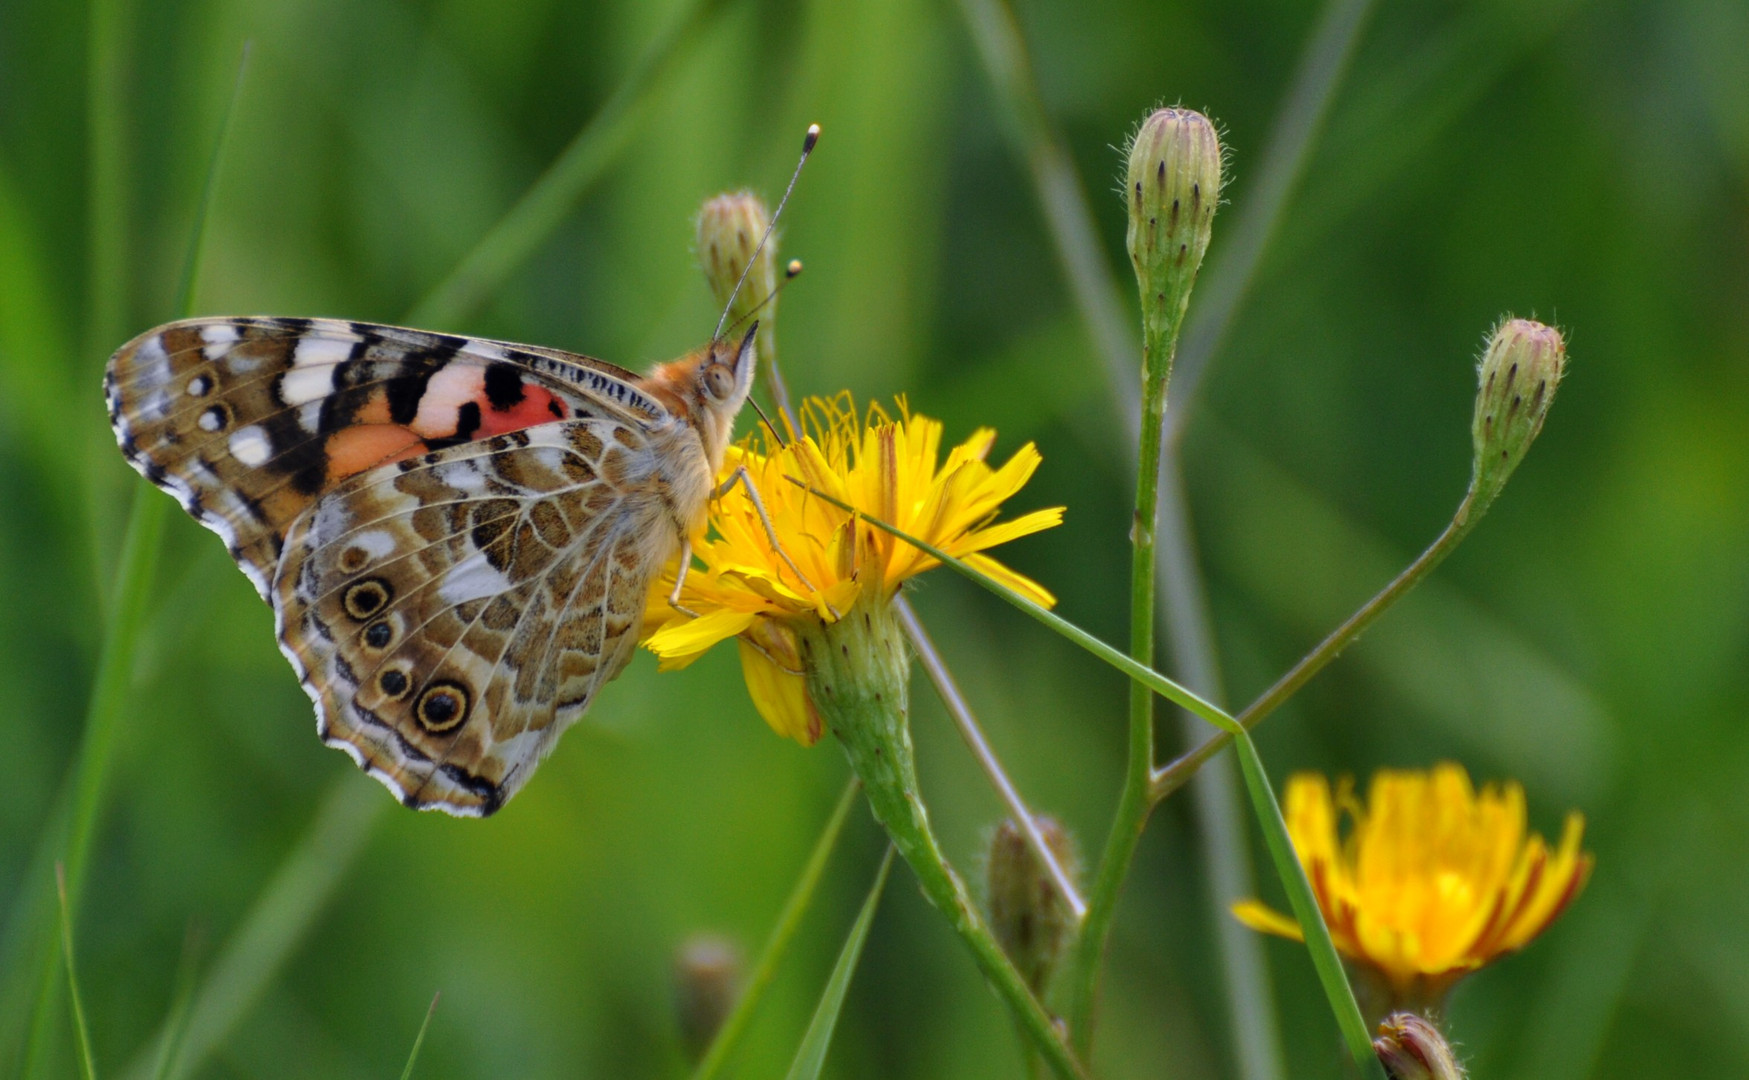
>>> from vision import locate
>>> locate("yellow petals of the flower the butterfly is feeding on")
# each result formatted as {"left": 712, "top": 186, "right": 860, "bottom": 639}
{"left": 644, "top": 394, "right": 1063, "bottom": 746}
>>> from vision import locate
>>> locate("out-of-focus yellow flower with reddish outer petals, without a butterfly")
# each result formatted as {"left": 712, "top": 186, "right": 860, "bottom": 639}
{"left": 1233, "top": 761, "right": 1592, "bottom": 1001}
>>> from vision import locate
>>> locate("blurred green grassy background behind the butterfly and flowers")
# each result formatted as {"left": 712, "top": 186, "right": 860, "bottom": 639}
{"left": 0, "top": 0, "right": 1749, "bottom": 1080}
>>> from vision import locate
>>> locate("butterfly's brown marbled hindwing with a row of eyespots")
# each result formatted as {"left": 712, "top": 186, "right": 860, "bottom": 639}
{"left": 275, "top": 420, "right": 673, "bottom": 814}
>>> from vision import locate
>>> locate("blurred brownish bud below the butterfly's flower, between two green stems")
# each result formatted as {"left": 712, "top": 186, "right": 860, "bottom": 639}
{"left": 986, "top": 816, "right": 1077, "bottom": 992}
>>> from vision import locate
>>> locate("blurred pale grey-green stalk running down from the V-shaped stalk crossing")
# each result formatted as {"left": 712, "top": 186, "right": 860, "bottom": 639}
{"left": 1158, "top": 458, "right": 1287, "bottom": 1080}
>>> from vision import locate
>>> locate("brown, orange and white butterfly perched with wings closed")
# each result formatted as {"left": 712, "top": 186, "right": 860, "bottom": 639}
{"left": 105, "top": 319, "right": 756, "bottom": 816}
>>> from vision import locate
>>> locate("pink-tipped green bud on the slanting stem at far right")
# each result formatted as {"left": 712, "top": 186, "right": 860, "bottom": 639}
{"left": 1471, "top": 319, "right": 1567, "bottom": 508}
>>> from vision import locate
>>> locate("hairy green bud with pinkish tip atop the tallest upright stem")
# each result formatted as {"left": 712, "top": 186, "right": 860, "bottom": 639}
{"left": 1125, "top": 109, "right": 1221, "bottom": 365}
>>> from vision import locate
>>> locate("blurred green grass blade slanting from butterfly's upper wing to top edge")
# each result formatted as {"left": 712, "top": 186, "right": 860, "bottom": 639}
{"left": 406, "top": 0, "right": 724, "bottom": 326}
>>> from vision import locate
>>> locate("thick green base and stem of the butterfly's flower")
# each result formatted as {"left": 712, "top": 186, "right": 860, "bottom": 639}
{"left": 798, "top": 597, "right": 1086, "bottom": 1080}
